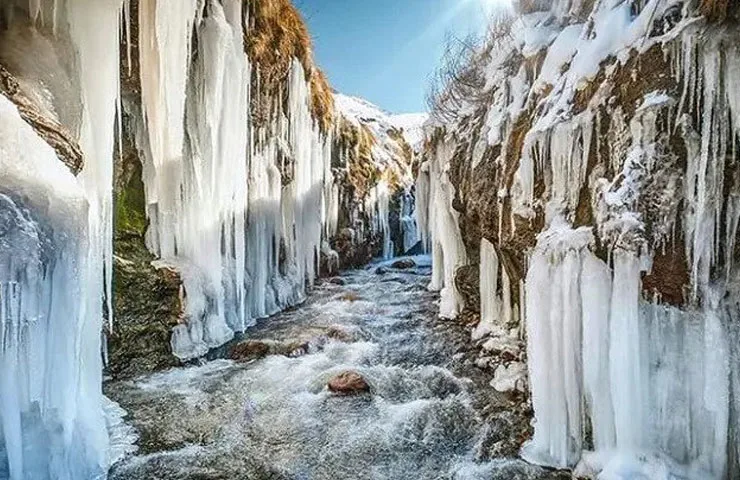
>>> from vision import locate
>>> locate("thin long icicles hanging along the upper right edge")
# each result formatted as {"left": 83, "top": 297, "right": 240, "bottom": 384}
{"left": 673, "top": 31, "right": 740, "bottom": 297}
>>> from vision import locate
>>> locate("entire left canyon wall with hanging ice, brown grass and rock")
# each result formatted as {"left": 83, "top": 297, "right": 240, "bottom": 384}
{"left": 0, "top": 0, "right": 412, "bottom": 474}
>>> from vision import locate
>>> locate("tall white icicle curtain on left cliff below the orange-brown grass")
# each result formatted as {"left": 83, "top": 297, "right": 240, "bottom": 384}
{"left": 138, "top": 0, "right": 338, "bottom": 359}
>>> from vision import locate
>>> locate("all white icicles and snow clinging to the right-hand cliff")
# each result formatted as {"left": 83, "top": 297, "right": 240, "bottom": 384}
{"left": 417, "top": 0, "right": 740, "bottom": 480}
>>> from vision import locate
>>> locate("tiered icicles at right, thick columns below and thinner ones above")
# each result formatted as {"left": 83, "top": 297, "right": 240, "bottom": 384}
{"left": 520, "top": 8, "right": 740, "bottom": 479}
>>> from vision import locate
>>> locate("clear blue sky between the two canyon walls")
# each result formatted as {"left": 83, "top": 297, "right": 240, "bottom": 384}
{"left": 294, "top": 0, "right": 503, "bottom": 113}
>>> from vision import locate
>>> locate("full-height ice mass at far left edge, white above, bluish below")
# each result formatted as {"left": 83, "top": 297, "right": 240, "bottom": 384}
{"left": 0, "top": 0, "right": 122, "bottom": 480}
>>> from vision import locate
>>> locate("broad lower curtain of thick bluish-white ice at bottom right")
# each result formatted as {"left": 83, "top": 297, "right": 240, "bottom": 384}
{"left": 522, "top": 222, "right": 731, "bottom": 479}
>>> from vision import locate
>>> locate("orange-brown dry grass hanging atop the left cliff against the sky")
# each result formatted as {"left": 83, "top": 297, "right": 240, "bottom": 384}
{"left": 245, "top": 0, "right": 334, "bottom": 131}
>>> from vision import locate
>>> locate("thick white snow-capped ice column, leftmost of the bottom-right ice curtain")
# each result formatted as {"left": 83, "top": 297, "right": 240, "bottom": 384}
{"left": 522, "top": 222, "right": 606, "bottom": 468}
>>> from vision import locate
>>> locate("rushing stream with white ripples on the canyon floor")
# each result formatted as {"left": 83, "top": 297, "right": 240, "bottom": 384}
{"left": 106, "top": 257, "right": 568, "bottom": 480}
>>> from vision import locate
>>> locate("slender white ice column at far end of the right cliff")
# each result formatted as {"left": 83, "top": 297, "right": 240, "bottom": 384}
{"left": 418, "top": 142, "right": 467, "bottom": 318}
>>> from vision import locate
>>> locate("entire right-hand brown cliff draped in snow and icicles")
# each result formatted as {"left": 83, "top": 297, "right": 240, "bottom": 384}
{"left": 417, "top": 0, "right": 740, "bottom": 479}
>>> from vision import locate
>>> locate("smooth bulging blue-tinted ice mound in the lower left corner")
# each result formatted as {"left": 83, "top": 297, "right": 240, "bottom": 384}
{"left": 0, "top": 95, "right": 108, "bottom": 480}
